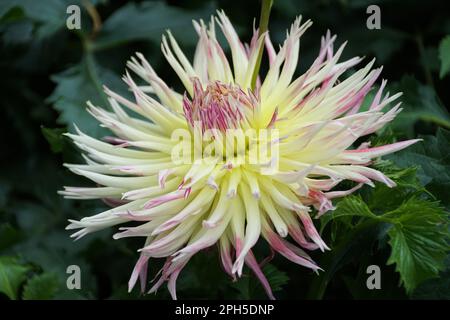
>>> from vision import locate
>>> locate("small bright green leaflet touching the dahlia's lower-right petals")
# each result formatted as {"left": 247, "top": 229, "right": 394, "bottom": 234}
{"left": 320, "top": 195, "right": 377, "bottom": 232}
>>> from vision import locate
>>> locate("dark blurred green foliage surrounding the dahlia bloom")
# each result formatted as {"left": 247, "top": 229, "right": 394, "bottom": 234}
{"left": 0, "top": 0, "right": 450, "bottom": 299}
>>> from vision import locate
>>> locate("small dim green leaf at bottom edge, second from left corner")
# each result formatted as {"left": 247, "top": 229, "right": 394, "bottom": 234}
{"left": 22, "top": 273, "right": 59, "bottom": 300}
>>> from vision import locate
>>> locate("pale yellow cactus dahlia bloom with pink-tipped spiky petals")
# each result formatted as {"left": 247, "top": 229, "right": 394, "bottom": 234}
{"left": 61, "top": 12, "right": 417, "bottom": 298}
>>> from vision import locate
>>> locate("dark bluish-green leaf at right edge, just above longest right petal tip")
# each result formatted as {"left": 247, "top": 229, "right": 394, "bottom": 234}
{"left": 389, "top": 76, "right": 450, "bottom": 137}
